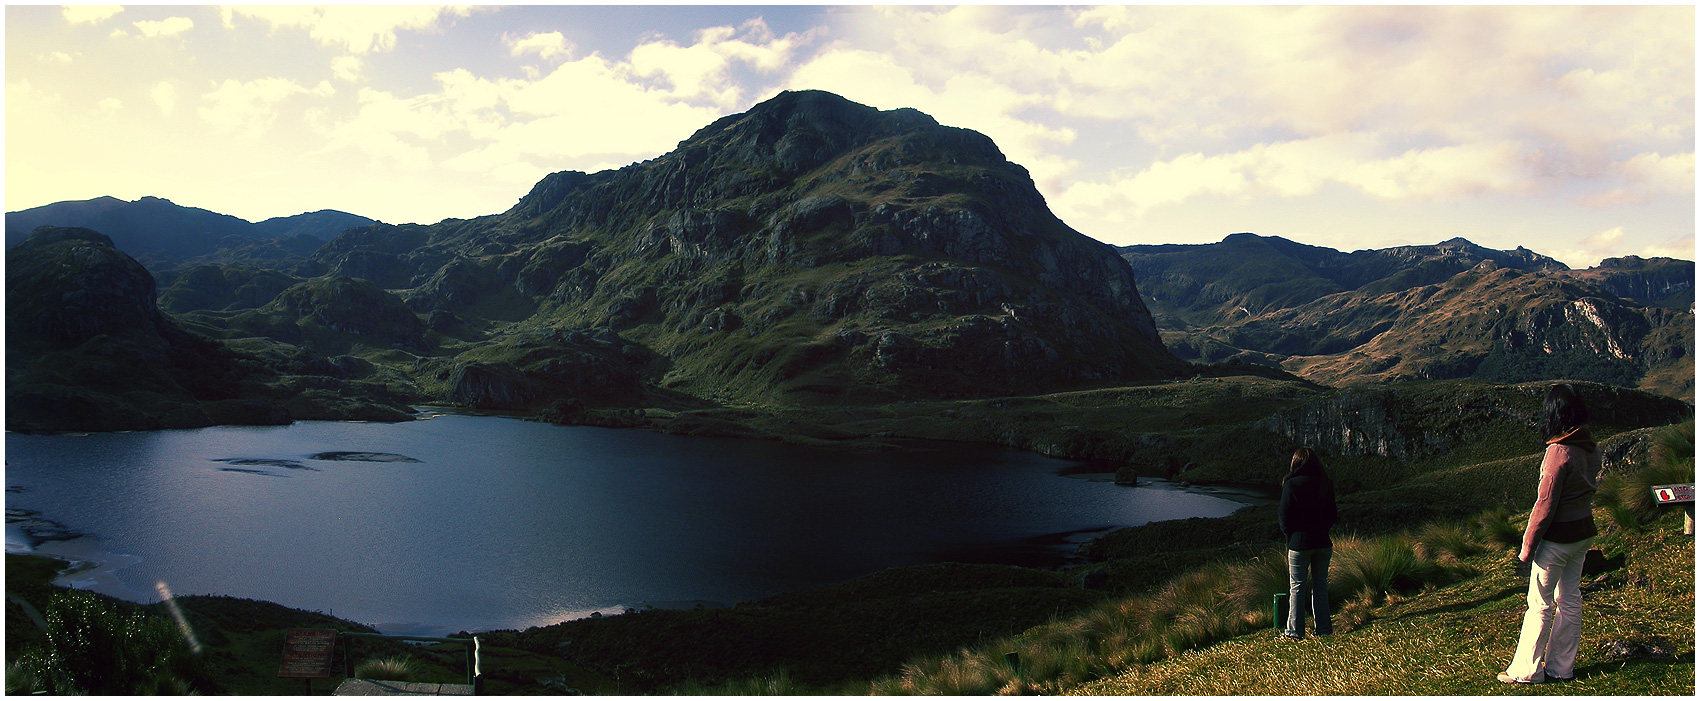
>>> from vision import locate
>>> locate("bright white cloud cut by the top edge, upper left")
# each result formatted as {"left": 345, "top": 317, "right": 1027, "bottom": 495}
{"left": 219, "top": 5, "right": 471, "bottom": 54}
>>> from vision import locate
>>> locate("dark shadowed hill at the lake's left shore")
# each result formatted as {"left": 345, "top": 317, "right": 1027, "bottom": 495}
{"left": 5, "top": 226, "right": 406, "bottom": 430}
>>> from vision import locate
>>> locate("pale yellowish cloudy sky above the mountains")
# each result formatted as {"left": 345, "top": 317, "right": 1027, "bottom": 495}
{"left": 5, "top": 5, "right": 1695, "bottom": 267}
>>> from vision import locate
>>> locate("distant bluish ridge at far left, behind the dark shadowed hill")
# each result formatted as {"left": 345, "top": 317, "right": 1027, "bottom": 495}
{"left": 5, "top": 197, "right": 372, "bottom": 274}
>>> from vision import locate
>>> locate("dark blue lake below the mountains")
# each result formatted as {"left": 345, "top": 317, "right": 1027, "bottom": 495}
{"left": 5, "top": 415, "right": 1241, "bottom": 635}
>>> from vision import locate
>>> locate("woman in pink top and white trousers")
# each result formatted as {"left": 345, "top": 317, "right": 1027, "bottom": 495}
{"left": 1499, "top": 385, "right": 1600, "bottom": 684}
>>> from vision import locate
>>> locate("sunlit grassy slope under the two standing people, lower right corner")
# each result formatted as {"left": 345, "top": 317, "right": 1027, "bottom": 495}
{"left": 1068, "top": 524, "right": 1695, "bottom": 696}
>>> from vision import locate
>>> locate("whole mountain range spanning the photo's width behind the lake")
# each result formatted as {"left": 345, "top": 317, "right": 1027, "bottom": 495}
{"left": 7, "top": 92, "right": 1695, "bottom": 435}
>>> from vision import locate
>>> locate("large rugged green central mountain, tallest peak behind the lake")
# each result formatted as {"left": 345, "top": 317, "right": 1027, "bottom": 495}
{"left": 172, "top": 92, "right": 1185, "bottom": 410}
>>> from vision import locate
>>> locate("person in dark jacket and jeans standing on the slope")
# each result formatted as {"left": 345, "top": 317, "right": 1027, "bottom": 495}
{"left": 1277, "top": 447, "right": 1338, "bottom": 638}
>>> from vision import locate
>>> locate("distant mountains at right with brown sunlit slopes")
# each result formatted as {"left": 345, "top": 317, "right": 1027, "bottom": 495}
{"left": 1120, "top": 235, "right": 1695, "bottom": 398}
